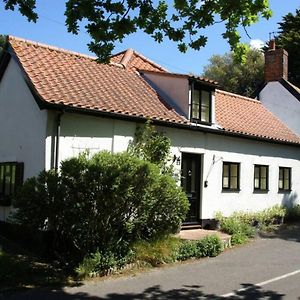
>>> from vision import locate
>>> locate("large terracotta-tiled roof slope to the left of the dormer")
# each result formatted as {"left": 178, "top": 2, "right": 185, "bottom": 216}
{"left": 9, "top": 37, "right": 186, "bottom": 123}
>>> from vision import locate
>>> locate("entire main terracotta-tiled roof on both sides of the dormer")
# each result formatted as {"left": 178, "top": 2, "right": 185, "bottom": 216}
{"left": 4, "top": 37, "right": 300, "bottom": 144}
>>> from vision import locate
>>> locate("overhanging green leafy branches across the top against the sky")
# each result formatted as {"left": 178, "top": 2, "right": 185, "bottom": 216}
{"left": 3, "top": 0, "right": 271, "bottom": 62}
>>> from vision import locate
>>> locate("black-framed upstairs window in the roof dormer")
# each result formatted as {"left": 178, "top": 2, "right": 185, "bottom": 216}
{"left": 191, "top": 84, "right": 211, "bottom": 123}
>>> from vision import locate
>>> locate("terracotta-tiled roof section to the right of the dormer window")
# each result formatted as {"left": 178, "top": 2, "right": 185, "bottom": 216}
{"left": 215, "top": 90, "right": 300, "bottom": 143}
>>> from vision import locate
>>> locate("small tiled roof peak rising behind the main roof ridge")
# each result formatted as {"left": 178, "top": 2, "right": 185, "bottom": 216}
{"left": 110, "top": 49, "right": 168, "bottom": 72}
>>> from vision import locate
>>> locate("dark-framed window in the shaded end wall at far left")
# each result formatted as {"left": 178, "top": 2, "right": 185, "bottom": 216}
{"left": 0, "top": 162, "right": 24, "bottom": 205}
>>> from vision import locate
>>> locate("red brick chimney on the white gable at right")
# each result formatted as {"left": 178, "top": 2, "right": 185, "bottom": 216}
{"left": 265, "top": 40, "right": 288, "bottom": 82}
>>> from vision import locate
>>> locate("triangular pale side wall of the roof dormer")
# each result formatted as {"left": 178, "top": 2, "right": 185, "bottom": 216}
{"left": 143, "top": 73, "right": 189, "bottom": 118}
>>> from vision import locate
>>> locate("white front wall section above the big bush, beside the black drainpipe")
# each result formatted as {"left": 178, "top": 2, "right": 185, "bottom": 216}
{"left": 46, "top": 112, "right": 136, "bottom": 170}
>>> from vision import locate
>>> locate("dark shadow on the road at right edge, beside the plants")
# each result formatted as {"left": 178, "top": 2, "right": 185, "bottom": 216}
{"left": 259, "top": 222, "right": 300, "bottom": 242}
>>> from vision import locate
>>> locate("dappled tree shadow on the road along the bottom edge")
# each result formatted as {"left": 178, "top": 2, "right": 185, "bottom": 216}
{"left": 0, "top": 283, "right": 285, "bottom": 300}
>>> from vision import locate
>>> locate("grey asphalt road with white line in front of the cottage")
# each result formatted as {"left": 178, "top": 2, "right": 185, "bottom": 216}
{"left": 0, "top": 224, "right": 300, "bottom": 300}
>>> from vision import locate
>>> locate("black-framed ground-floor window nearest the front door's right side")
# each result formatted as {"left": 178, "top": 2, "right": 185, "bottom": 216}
{"left": 222, "top": 162, "right": 240, "bottom": 190}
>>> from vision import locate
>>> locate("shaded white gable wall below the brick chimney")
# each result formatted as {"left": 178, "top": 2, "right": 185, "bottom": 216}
{"left": 259, "top": 81, "right": 300, "bottom": 135}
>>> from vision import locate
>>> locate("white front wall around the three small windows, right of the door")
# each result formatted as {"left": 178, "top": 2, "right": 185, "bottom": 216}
{"left": 167, "top": 125, "right": 300, "bottom": 219}
